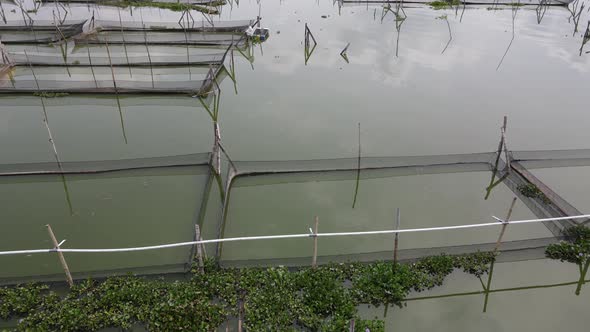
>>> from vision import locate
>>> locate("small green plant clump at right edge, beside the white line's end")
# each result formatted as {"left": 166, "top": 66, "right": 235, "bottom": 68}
{"left": 545, "top": 225, "right": 590, "bottom": 295}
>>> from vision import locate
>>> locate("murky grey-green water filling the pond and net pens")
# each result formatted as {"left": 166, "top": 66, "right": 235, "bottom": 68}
{"left": 0, "top": 0, "right": 590, "bottom": 331}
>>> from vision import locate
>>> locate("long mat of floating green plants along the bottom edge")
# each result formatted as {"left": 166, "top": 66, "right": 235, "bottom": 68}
{"left": 0, "top": 253, "right": 495, "bottom": 332}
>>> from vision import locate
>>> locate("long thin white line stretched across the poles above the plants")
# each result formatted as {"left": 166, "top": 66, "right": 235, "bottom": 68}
{"left": 0, "top": 214, "right": 590, "bottom": 256}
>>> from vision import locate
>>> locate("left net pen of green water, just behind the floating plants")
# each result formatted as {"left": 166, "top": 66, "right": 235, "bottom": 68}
{"left": 0, "top": 163, "right": 211, "bottom": 284}
